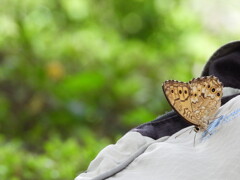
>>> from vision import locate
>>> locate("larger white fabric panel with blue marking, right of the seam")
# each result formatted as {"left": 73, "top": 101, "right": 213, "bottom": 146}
{"left": 108, "top": 96, "right": 240, "bottom": 180}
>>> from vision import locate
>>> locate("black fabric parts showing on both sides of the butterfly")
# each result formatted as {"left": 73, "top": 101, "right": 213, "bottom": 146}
{"left": 131, "top": 41, "right": 240, "bottom": 139}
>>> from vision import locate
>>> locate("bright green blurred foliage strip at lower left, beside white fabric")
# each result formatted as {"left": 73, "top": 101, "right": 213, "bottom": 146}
{"left": 0, "top": 133, "right": 109, "bottom": 180}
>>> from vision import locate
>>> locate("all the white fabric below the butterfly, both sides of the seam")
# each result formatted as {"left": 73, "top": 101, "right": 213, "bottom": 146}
{"left": 75, "top": 96, "right": 240, "bottom": 180}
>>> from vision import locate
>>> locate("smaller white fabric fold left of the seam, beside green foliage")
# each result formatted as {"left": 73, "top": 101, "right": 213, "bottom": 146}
{"left": 75, "top": 132, "right": 166, "bottom": 180}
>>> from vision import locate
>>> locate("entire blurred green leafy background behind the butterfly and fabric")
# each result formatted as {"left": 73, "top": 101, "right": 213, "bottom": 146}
{"left": 0, "top": 0, "right": 240, "bottom": 180}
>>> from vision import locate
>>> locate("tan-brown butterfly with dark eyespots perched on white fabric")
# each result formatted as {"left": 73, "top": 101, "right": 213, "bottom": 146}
{"left": 162, "top": 76, "right": 223, "bottom": 132}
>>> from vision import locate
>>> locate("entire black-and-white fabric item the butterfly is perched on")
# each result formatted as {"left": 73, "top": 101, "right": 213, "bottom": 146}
{"left": 75, "top": 41, "right": 240, "bottom": 180}
